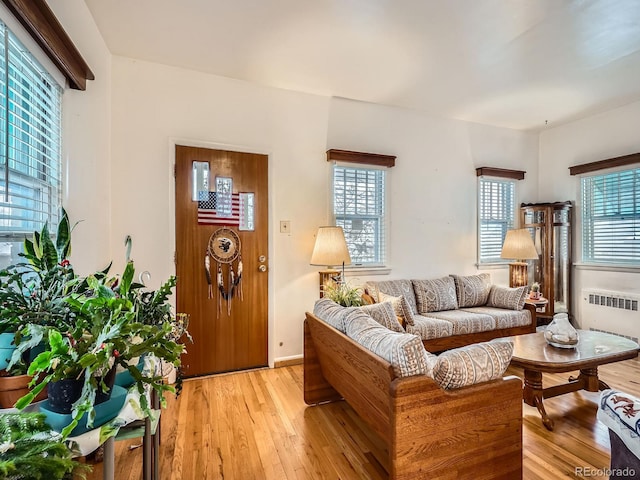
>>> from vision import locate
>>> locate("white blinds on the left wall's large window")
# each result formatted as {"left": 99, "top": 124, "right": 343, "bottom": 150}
{"left": 0, "top": 22, "right": 62, "bottom": 240}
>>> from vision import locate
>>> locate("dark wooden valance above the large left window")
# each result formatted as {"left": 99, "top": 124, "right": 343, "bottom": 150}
{"left": 2, "top": 0, "right": 95, "bottom": 90}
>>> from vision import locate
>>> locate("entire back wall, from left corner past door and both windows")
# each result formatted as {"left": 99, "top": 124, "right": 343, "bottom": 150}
{"left": 111, "top": 57, "right": 538, "bottom": 361}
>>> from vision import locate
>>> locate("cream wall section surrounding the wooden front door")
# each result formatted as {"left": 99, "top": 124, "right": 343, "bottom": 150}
{"left": 111, "top": 57, "right": 329, "bottom": 361}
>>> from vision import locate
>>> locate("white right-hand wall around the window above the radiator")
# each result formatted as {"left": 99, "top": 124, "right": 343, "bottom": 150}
{"left": 539, "top": 102, "right": 640, "bottom": 337}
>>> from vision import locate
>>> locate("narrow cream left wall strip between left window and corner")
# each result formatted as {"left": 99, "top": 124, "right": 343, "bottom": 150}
{"left": 48, "top": 0, "right": 112, "bottom": 274}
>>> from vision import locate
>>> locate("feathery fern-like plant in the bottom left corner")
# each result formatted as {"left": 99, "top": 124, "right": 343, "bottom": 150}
{"left": 0, "top": 413, "right": 90, "bottom": 480}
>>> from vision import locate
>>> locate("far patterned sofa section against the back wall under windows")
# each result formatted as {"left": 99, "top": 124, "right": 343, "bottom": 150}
{"left": 364, "top": 273, "right": 537, "bottom": 352}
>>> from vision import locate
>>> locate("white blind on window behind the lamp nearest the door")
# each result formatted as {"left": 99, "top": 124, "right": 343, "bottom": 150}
{"left": 333, "top": 165, "right": 386, "bottom": 267}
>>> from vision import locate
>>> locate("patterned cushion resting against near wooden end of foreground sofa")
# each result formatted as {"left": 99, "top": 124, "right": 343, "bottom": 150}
{"left": 433, "top": 340, "right": 513, "bottom": 389}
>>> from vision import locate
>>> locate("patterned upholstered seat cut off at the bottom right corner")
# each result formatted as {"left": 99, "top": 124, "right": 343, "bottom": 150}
{"left": 597, "top": 389, "right": 640, "bottom": 480}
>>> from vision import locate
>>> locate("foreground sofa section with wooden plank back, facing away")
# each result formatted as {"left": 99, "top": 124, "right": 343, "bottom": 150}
{"left": 304, "top": 299, "right": 522, "bottom": 480}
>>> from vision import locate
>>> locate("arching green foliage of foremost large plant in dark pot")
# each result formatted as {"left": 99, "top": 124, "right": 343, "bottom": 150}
{"left": 16, "top": 262, "right": 184, "bottom": 437}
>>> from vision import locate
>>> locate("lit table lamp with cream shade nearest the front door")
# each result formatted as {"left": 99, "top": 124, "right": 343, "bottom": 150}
{"left": 311, "top": 227, "right": 351, "bottom": 298}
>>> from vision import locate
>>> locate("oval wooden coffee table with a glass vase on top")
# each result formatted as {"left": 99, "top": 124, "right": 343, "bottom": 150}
{"left": 510, "top": 330, "right": 639, "bottom": 430}
